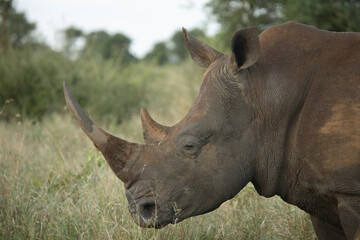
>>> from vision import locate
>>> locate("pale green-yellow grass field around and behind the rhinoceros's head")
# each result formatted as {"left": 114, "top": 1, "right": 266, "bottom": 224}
{"left": 0, "top": 60, "right": 315, "bottom": 240}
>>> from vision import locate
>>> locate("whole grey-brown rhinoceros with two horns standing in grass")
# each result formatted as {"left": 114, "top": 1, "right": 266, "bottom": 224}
{"left": 64, "top": 22, "right": 360, "bottom": 240}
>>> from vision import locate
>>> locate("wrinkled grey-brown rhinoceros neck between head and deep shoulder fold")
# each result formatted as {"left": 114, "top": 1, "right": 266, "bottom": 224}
{"left": 250, "top": 49, "right": 316, "bottom": 197}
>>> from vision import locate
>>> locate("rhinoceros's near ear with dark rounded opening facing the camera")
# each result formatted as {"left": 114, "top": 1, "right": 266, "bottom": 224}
{"left": 229, "top": 27, "right": 260, "bottom": 71}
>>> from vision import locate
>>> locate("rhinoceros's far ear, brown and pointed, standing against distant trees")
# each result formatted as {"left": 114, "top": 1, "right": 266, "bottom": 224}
{"left": 183, "top": 28, "right": 223, "bottom": 68}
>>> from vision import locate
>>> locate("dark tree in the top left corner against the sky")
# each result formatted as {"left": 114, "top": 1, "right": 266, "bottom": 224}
{"left": 0, "top": 0, "right": 36, "bottom": 49}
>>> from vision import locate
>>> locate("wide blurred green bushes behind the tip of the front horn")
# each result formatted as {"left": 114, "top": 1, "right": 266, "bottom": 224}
{"left": 0, "top": 48, "right": 157, "bottom": 122}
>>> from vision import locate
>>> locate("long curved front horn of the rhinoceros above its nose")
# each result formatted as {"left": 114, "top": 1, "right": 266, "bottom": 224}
{"left": 63, "top": 82, "right": 140, "bottom": 182}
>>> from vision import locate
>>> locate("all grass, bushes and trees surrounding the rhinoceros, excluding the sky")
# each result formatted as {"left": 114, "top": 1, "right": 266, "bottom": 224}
{"left": 0, "top": 0, "right": 360, "bottom": 239}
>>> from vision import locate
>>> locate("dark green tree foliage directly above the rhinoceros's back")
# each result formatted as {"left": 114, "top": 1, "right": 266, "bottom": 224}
{"left": 207, "top": 0, "right": 360, "bottom": 48}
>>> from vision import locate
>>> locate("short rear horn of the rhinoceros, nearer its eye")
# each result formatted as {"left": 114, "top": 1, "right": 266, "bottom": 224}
{"left": 140, "top": 108, "right": 169, "bottom": 144}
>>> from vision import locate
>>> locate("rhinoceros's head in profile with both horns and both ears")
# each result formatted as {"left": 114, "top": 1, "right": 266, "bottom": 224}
{"left": 64, "top": 28, "right": 260, "bottom": 228}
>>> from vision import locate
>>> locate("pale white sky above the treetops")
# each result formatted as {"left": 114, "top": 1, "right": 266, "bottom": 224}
{"left": 15, "top": 0, "right": 217, "bottom": 57}
